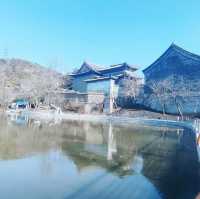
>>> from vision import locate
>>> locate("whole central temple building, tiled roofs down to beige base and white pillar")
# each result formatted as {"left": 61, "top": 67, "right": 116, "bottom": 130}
{"left": 66, "top": 62, "right": 140, "bottom": 113}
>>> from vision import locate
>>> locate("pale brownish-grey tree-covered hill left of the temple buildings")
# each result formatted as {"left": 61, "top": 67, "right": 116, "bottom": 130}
{"left": 0, "top": 59, "right": 64, "bottom": 105}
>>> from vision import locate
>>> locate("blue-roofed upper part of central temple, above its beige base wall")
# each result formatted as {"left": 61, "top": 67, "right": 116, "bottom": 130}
{"left": 71, "top": 62, "right": 137, "bottom": 95}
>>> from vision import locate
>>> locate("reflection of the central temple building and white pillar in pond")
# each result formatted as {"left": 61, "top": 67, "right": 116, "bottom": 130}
{"left": 62, "top": 122, "right": 147, "bottom": 175}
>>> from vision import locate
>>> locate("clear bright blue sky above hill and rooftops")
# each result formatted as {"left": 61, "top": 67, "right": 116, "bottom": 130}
{"left": 0, "top": 0, "right": 200, "bottom": 72}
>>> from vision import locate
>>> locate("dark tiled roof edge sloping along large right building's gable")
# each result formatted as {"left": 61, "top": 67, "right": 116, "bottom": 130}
{"left": 143, "top": 43, "right": 200, "bottom": 73}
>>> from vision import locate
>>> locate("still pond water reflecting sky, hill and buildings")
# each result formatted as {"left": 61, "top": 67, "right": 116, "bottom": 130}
{"left": 0, "top": 115, "right": 200, "bottom": 199}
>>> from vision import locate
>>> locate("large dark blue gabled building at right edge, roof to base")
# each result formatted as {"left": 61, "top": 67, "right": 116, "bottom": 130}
{"left": 143, "top": 44, "right": 200, "bottom": 114}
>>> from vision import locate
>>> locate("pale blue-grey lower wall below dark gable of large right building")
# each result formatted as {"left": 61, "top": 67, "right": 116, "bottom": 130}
{"left": 140, "top": 75, "right": 200, "bottom": 115}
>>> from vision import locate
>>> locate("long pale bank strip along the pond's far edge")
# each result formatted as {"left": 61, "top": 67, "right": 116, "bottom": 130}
{"left": 16, "top": 111, "right": 192, "bottom": 132}
